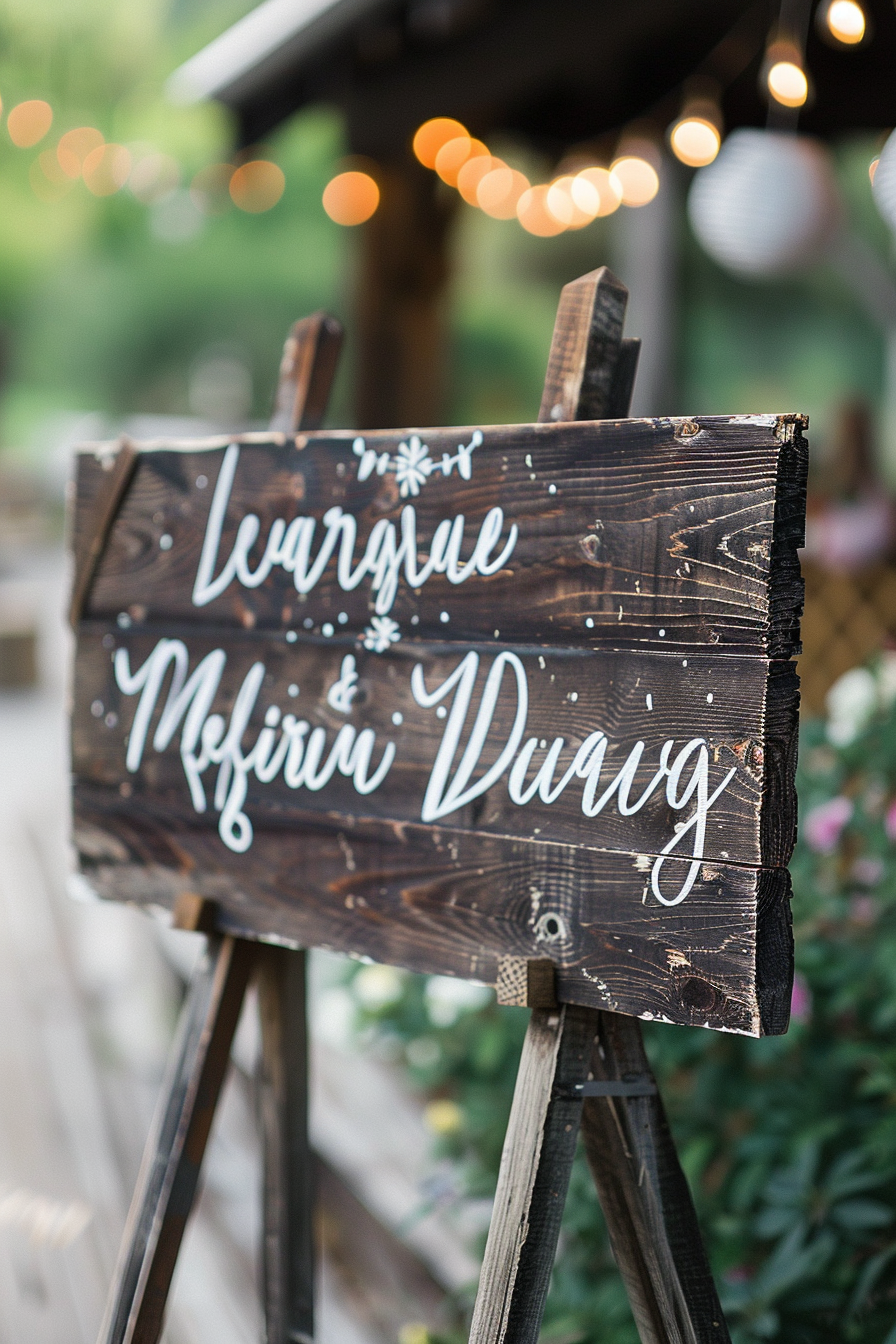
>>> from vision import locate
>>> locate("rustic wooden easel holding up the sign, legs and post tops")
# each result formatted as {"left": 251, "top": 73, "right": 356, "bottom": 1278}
{"left": 94, "top": 269, "right": 729, "bottom": 1344}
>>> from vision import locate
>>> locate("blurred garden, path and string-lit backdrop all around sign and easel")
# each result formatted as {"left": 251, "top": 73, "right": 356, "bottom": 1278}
{"left": 8, "top": 0, "right": 896, "bottom": 1344}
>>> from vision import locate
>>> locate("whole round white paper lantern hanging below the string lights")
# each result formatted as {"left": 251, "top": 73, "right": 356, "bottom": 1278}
{"left": 688, "top": 130, "right": 843, "bottom": 276}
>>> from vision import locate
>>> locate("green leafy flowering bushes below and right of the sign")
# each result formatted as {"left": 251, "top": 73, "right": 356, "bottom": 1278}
{"left": 346, "top": 659, "right": 896, "bottom": 1344}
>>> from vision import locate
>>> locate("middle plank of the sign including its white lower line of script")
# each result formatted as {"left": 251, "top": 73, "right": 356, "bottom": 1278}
{"left": 73, "top": 622, "right": 798, "bottom": 876}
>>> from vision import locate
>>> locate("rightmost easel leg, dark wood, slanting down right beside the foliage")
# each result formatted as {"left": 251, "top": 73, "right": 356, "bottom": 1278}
{"left": 582, "top": 1012, "right": 729, "bottom": 1344}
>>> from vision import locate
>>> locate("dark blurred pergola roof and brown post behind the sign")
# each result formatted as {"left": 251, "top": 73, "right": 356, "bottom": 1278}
{"left": 169, "top": 0, "right": 896, "bottom": 427}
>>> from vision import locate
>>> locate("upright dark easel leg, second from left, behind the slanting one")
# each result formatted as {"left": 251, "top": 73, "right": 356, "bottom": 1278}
{"left": 258, "top": 946, "right": 314, "bottom": 1344}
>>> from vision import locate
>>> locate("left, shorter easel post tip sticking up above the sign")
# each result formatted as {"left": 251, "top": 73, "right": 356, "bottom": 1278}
{"left": 269, "top": 313, "right": 344, "bottom": 434}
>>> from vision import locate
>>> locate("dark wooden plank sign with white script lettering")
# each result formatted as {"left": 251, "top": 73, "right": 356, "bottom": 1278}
{"left": 73, "top": 403, "right": 806, "bottom": 1032}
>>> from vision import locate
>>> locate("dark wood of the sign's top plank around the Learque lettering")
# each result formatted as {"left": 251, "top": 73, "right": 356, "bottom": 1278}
{"left": 75, "top": 415, "right": 807, "bottom": 659}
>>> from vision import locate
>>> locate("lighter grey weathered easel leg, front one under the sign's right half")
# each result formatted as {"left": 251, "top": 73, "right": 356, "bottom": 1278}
{"left": 470, "top": 1004, "right": 596, "bottom": 1344}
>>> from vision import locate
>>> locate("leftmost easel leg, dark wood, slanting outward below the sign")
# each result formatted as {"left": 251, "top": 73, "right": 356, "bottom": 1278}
{"left": 99, "top": 935, "right": 255, "bottom": 1344}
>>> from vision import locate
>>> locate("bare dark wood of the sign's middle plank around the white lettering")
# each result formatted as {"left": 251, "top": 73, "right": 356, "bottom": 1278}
{"left": 73, "top": 622, "right": 798, "bottom": 866}
